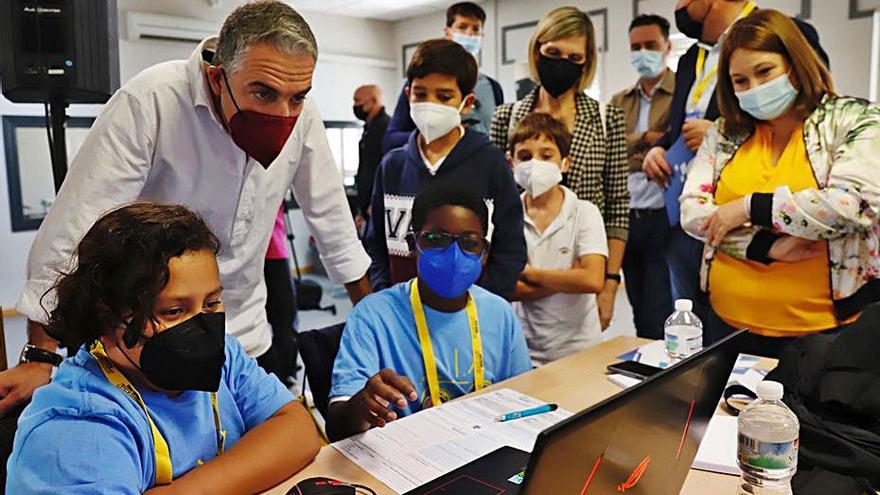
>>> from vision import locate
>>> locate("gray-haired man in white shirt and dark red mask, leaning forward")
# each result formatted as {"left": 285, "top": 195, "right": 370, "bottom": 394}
{"left": 0, "top": 0, "right": 370, "bottom": 416}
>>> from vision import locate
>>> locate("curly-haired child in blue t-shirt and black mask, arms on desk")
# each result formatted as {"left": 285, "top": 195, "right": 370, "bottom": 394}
{"left": 6, "top": 203, "right": 320, "bottom": 495}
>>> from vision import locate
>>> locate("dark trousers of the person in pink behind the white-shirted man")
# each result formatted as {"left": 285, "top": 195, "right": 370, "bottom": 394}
{"left": 257, "top": 259, "right": 299, "bottom": 380}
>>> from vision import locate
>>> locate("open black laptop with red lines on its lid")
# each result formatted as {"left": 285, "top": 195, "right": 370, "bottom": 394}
{"left": 405, "top": 330, "right": 746, "bottom": 495}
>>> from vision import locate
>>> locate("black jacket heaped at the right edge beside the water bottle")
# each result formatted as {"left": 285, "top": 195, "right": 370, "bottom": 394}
{"left": 767, "top": 304, "right": 880, "bottom": 495}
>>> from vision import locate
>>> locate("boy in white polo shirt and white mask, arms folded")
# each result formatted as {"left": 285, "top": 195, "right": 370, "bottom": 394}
{"left": 510, "top": 113, "right": 608, "bottom": 365}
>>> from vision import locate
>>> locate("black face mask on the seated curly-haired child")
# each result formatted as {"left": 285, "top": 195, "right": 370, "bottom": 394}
{"left": 125, "top": 313, "right": 226, "bottom": 392}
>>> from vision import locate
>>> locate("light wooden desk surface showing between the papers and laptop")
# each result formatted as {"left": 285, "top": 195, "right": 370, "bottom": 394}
{"left": 265, "top": 337, "right": 739, "bottom": 495}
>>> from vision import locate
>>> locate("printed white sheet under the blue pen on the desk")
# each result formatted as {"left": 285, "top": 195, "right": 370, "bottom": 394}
{"left": 333, "top": 389, "right": 571, "bottom": 493}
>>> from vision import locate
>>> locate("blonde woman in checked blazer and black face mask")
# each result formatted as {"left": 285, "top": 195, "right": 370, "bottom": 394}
{"left": 490, "top": 7, "right": 629, "bottom": 330}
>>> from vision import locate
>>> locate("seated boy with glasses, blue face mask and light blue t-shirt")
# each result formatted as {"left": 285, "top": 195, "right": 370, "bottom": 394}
{"left": 327, "top": 183, "right": 531, "bottom": 440}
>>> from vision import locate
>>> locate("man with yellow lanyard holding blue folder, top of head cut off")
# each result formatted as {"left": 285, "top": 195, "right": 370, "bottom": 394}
{"left": 642, "top": 0, "right": 828, "bottom": 314}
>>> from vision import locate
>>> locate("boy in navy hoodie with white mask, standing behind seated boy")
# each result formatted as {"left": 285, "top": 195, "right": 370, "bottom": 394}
{"left": 365, "top": 40, "right": 527, "bottom": 295}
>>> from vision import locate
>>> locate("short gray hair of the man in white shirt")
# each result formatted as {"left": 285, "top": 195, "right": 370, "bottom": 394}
{"left": 212, "top": 0, "right": 318, "bottom": 73}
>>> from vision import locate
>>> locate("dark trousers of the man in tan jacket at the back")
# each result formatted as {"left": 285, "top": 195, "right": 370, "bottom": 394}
{"left": 623, "top": 208, "right": 673, "bottom": 339}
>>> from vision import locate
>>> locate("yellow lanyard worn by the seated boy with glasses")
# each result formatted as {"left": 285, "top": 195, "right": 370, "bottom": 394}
{"left": 409, "top": 279, "right": 486, "bottom": 406}
